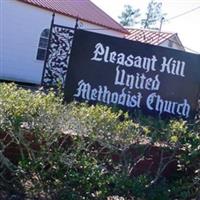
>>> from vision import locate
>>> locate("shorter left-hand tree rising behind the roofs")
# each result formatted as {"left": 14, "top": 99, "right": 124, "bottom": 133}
{"left": 119, "top": 5, "right": 140, "bottom": 26}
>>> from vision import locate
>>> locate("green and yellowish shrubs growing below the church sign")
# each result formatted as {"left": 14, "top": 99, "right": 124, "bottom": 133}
{"left": 0, "top": 84, "right": 200, "bottom": 200}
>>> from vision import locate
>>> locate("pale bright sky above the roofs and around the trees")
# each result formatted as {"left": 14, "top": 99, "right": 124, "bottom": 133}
{"left": 91, "top": 0, "right": 200, "bottom": 54}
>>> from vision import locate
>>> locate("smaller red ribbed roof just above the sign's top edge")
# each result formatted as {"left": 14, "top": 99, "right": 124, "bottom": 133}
{"left": 125, "top": 29, "right": 176, "bottom": 45}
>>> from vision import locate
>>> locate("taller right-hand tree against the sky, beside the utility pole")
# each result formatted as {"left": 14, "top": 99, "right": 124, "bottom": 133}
{"left": 141, "top": 0, "right": 166, "bottom": 29}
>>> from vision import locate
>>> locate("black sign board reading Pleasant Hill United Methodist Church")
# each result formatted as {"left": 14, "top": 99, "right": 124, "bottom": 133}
{"left": 65, "top": 30, "right": 200, "bottom": 118}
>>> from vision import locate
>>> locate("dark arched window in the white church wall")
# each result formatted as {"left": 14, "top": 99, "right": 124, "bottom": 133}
{"left": 37, "top": 29, "right": 49, "bottom": 60}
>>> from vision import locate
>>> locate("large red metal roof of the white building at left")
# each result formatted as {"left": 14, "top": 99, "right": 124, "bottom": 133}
{"left": 19, "top": 0, "right": 128, "bottom": 34}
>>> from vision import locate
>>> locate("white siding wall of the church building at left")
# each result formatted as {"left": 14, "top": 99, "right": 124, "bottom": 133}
{"left": 0, "top": 0, "right": 123, "bottom": 84}
